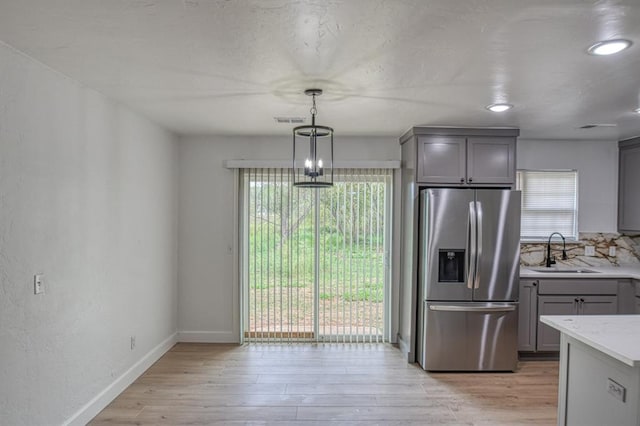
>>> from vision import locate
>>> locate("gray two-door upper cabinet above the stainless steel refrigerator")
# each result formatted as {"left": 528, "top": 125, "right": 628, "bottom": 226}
{"left": 400, "top": 127, "right": 519, "bottom": 187}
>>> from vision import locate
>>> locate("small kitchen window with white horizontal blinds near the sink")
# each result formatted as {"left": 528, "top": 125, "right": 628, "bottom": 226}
{"left": 516, "top": 170, "right": 578, "bottom": 240}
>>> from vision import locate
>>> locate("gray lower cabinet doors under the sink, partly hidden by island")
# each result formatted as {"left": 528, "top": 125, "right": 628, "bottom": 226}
{"left": 536, "top": 296, "right": 618, "bottom": 351}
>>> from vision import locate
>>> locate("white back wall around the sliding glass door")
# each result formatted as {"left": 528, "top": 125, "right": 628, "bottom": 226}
{"left": 178, "top": 137, "right": 400, "bottom": 342}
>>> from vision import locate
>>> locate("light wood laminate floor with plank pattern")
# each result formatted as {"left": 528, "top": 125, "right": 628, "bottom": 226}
{"left": 90, "top": 343, "right": 558, "bottom": 426}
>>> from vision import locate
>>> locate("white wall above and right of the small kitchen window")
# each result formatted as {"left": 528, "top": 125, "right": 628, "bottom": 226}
{"left": 517, "top": 139, "right": 618, "bottom": 232}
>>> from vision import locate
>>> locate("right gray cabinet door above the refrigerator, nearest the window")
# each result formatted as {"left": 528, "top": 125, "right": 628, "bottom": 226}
{"left": 467, "top": 136, "right": 516, "bottom": 185}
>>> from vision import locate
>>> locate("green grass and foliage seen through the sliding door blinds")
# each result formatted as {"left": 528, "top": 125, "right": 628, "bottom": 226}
{"left": 247, "top": 182, "right": 385, "bottom": 302}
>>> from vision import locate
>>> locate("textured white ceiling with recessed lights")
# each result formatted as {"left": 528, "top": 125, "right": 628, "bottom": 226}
{"left": 0, "top": 0, "right": 640, "bottom": 139}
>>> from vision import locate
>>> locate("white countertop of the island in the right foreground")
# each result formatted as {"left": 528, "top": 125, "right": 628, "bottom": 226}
{"left": 540, "top": 314, "right": 640, "bottom": 367}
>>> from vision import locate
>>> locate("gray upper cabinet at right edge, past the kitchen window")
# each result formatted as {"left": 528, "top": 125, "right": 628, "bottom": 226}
{"left": 618, "top": 137, "right": 640, "bottom": 232}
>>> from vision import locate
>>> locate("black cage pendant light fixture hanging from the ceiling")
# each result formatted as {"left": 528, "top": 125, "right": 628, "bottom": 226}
{"left": 293, "top": 89, "right": 333, "bottom": 188}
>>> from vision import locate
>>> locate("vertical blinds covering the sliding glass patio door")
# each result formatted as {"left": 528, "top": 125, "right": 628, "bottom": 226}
{"left": 242, "top": 168, "right": 391, "bottom": 342}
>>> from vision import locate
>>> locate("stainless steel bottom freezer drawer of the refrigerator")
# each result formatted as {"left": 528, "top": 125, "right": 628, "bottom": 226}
{"left": 422, "top": 302, "right": 518, "bottom": 371}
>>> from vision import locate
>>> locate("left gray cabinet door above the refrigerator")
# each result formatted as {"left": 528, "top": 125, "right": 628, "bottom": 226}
{"left": 416, "top": 136, "right": 467, "bottom": 185}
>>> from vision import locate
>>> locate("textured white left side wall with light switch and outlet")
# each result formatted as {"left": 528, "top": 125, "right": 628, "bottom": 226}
{"left": 0, "top": 44, "right": 177, "bottom": 425}
